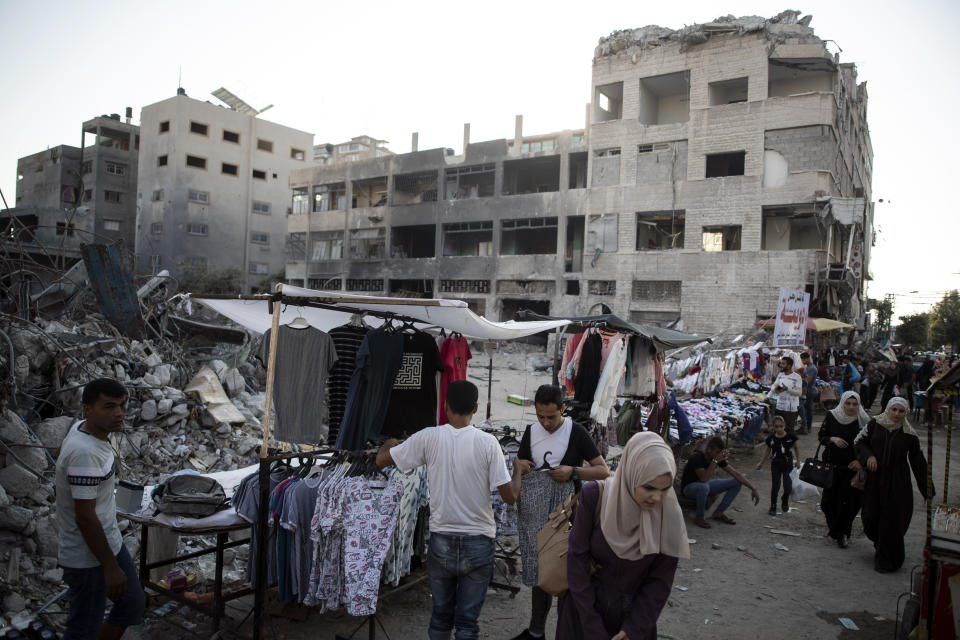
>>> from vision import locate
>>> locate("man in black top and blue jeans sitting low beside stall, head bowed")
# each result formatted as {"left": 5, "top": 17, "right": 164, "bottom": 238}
{"left": 680, "top": 436, "right": 760, "bottom": 529}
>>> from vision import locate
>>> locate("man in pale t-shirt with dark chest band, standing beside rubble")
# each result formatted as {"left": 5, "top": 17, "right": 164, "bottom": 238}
{"left": 56, "top": 378, "right": 146, "bottom": 640}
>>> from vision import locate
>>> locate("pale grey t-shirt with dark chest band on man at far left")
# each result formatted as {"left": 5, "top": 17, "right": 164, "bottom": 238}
{"left": 56, "top": 422, "right": 123, "bottom": 569}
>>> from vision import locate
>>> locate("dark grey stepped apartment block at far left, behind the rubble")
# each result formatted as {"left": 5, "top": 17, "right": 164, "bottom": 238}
{"left": 0, "top": 112, "right": 140, "bottom": 270}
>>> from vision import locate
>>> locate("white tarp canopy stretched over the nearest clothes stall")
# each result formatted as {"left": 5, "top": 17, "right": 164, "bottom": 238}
{"left": 191, "top": 284, "right": 570, "bottom": 340}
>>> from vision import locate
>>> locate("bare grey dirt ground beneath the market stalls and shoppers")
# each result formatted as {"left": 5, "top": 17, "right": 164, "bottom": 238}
{"left": 137, "top": 352, "right": 960, "bottom": 640}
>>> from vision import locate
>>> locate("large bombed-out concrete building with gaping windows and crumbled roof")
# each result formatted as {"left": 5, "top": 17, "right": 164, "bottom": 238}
{"left": 286, "top": 11, "right": 873, "bottom": 333}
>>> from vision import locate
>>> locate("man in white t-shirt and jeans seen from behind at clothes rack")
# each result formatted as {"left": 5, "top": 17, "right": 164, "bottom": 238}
{"left": 377, "top": 380, "right": 520, "bottom": 640}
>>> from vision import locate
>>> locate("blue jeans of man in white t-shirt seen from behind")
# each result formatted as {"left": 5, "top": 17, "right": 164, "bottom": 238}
{"left": 427, "top": 533, "right": 493, "bottom": 640}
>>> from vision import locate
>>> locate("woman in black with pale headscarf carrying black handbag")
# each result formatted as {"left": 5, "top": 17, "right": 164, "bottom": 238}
{"left": 817, "top": 391, "right": 870, "bottom": 549}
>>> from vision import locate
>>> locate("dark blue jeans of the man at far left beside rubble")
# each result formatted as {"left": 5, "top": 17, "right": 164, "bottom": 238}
{"left": 63, "top": 546, "right": 146, "bottom": 640}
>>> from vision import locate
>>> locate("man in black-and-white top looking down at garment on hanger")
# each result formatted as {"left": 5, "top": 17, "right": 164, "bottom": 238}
{"left": 513, "top": 384, "right": 610, "bottom": 640}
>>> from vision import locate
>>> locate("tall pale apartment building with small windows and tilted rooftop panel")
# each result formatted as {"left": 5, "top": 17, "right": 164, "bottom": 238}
{"left": 137, "top": 89, "right": 313, "bottom": 291}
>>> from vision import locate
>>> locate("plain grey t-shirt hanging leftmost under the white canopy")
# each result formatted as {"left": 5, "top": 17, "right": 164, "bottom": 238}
{"left": 260, "top": 325, "right": 337, "bottom": 444}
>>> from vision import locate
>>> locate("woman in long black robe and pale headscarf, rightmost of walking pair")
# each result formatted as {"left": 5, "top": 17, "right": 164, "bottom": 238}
{"left": 855, "top": 397, "right": 927, "bottom": 573}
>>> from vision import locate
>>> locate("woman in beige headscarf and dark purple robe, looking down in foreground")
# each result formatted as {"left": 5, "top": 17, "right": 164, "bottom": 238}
{"left": 556, "top": 431, "right": 690, "bottom": 640}
